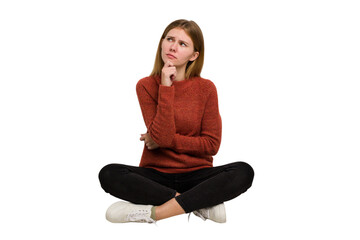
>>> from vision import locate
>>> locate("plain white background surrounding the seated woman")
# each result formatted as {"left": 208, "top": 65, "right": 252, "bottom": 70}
{"left": 0, "top": 0, "right": 360, "bottom": 240}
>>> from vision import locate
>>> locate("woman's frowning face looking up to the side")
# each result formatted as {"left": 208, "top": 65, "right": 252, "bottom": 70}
{"left": 161, "top": 28, "right": 199, "bottom": 67}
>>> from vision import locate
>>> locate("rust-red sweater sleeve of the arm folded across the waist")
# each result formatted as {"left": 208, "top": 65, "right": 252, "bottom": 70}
{"left": 172, "top": 85, "right": 222, "bottom": 156}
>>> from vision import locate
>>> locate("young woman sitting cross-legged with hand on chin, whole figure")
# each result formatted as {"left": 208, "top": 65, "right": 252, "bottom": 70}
{"left": 99, "top": 20, "right": 254, "bottom": 223}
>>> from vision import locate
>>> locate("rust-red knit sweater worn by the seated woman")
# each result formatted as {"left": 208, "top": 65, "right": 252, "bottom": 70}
{"left": 136, "top": 76, "right": 221, "bottom": 173}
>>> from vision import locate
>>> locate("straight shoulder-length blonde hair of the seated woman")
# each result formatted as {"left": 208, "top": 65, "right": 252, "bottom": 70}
{"left": 150, "top": 19, "right": 205, "bottom": 79}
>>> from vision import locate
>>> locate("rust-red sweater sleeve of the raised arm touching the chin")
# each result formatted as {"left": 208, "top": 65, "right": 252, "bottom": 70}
{"left": 136, "top": 82, "right": 176, "bottom": 147}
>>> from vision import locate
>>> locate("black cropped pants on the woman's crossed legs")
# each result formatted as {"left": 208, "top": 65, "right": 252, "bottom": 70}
{"left": 99, "top": 162, "right": 254, "bottom": 213}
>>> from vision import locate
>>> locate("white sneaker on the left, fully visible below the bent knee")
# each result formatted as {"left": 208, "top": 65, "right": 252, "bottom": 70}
{"left": 106, "top": 201, "right": 155, "bottom": 223}
